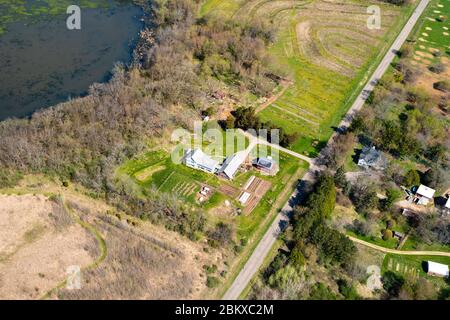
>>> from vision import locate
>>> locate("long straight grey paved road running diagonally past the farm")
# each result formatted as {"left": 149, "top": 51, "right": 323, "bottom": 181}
{"left": 223, "top": 0, "right": 430, "bottom": 300}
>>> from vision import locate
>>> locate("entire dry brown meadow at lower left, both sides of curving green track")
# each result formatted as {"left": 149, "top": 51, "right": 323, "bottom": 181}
{"left": 0, "top": 176, "right": 222, "bottom": 299}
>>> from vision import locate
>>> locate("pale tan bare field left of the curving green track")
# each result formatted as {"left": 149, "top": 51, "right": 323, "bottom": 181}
{"left": 0, "top": 195, "right": 96, "bottom": 299}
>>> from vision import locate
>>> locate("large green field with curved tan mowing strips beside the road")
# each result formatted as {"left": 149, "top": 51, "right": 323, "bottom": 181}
{"left": 201, "top": 0, "right": 414, "bottom": 156}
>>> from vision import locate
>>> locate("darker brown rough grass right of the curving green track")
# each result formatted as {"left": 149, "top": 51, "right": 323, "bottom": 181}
{"left": 57, "top": 212, "right": 218, "bottom": 300}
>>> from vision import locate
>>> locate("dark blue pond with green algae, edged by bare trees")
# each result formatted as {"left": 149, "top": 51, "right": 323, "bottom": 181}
{"left": 0, "top": 0, "right": 143, "bottom": 120}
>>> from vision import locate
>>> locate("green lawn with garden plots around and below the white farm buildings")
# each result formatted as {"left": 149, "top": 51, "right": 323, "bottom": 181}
{"left": 117, "top": 142, "right": 308, "bottom": 240}
